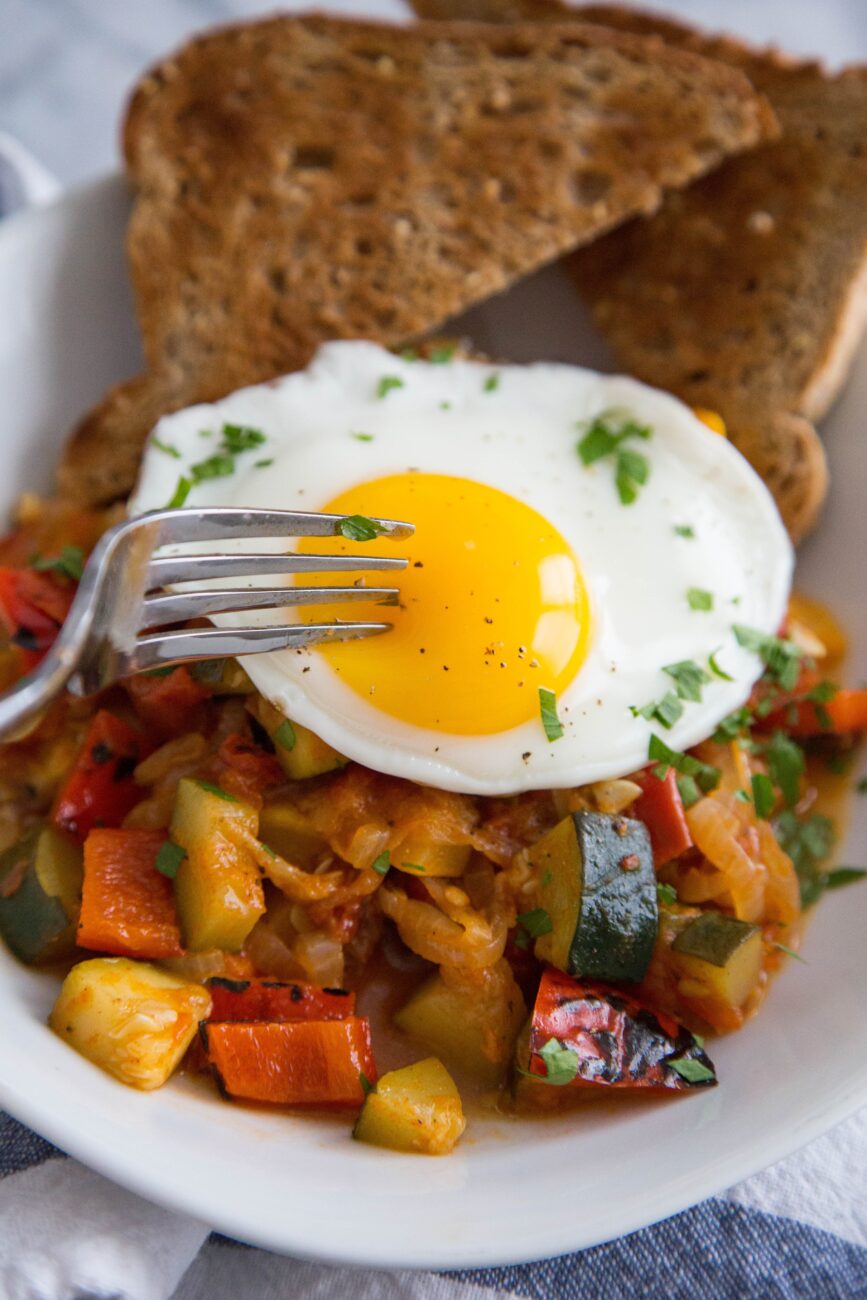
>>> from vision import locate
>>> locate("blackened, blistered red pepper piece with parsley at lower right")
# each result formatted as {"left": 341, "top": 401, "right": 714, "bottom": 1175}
{"left": 519, "top": 969, "right": 716, "bottom": 1095}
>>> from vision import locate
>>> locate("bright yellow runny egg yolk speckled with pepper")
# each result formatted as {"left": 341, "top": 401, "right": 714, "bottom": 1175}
{"left": 298, "top": 472, "right": 590, "bottom": 736}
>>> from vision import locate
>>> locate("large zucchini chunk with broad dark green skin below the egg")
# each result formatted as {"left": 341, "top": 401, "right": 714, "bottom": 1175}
{"left": 529, "top": 813, "right": 658, "bottom": 982}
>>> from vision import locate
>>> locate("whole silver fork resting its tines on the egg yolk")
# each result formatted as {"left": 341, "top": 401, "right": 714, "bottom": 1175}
{"left": 0, "top": 508, "right": 413, "bottom": 738}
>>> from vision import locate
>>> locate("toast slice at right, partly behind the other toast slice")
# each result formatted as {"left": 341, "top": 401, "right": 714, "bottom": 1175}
{"left": 415, "top": 0, "right": 867, "bottom": 538}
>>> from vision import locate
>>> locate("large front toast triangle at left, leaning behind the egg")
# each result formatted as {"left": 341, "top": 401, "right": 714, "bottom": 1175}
{"left": 60, "top": 16, "right": 776, "bottom": 502}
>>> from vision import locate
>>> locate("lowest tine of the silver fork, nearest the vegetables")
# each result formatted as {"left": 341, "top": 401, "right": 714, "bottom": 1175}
{"left": 117, "top": 623, "right": 391, "bottom": 677}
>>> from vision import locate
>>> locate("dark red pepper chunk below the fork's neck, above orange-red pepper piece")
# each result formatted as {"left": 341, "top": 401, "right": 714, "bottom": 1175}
{"left": 52, "top": 709, "right": 142, "bottom": 842}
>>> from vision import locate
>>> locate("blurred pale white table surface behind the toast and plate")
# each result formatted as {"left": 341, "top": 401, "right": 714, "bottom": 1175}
{"left": 0, "top": 0, "right": 867, "bottom": 183}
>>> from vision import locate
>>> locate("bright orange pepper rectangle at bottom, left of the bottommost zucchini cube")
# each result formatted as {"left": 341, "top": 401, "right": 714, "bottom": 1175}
{"left": 206, "top": 1015, "right": 377, "bottom": 1106}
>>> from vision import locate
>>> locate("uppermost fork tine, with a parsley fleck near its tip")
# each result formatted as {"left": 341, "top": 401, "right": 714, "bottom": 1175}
{"left": 146, "top": 506, "right": 413, "bottom": 546}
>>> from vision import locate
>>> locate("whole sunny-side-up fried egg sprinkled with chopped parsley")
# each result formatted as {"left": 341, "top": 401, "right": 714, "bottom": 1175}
{"left": 131, "top": 342, "right": 793, "bottom": 794}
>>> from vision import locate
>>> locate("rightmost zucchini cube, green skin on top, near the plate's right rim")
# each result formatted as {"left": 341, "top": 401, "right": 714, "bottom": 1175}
{"left": 672, "top": 911, "right": 762, "bottom": 1008}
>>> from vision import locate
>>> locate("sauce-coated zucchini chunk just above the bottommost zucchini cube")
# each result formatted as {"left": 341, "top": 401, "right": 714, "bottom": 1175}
{"left": 394, "top": 972, "right": 526, "bottom": 1088}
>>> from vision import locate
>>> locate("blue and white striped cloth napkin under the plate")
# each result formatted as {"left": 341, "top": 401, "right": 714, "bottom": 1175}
{"left": 0, "top": 134, "right": 867, "bottom": 1300}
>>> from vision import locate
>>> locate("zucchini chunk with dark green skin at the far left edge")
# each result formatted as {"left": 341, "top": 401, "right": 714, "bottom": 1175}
{"left": 0, "top": 826, "right": 82, "bottom": 963}
